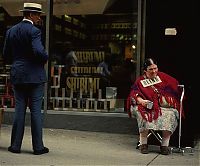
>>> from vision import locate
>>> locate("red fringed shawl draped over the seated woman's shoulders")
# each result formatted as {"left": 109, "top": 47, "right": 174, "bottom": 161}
{"left": 127, "top": 72, "right": 184, "bottom": 121}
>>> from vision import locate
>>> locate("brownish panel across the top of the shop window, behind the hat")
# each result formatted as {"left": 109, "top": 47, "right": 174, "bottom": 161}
{"left": 0, "top": 0, "right": 113, "bottom": 16}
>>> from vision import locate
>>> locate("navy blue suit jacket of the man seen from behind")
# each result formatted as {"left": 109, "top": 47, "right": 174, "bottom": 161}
{"left": 3, "top": 20, "right": 48, "bottom": 84}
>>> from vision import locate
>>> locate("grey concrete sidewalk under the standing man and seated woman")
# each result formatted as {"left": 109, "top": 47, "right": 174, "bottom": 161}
{"left": 0, "top": 124, "right": 200, "bottom": 166}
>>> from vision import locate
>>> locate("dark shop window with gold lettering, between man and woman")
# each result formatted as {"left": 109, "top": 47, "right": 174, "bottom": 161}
{"left": 0, "top": 0, "right": 137, "bottom": 112}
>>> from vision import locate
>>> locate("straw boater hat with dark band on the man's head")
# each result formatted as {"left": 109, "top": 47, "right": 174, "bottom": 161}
{"left": 20, "top": 3, "right": 44, "bottom": 13}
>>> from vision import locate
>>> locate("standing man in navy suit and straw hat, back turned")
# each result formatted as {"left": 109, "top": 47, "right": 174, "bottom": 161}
{"left": 3, "top": 3, "right": 49, "bottom": 155}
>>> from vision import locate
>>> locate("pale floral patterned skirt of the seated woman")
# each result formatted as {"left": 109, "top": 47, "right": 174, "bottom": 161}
{"left": 131, "top": 106, "right": 179, "bottom": 133}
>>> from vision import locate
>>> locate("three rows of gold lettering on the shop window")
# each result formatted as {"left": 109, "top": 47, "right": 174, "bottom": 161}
{"left": 66, "top": 50, "right": 105, "bottom": 93}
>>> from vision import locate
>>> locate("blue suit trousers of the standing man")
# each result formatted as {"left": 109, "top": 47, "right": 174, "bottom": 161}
{"left": 11, "top": 83, "right": 44, "bottom": 150}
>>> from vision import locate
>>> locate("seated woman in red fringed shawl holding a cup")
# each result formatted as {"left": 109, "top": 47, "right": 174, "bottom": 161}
{"left": 127, "top": 58, "right": 184, "bottom": 155}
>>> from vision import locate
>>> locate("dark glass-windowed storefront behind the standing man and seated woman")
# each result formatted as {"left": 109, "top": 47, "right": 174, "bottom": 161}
{"left": 0, "top": 0, "right": 199, "bottom": 143}
